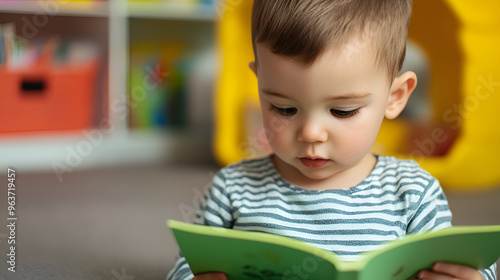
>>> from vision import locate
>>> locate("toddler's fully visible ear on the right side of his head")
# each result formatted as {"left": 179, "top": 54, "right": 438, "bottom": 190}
{"left": 385, "top": 71, "right": 417, "bottom": 120}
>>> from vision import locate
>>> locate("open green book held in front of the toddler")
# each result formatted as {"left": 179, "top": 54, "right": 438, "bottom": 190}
{"left": 167, "top": 220, "right": 500, "bottom": 280}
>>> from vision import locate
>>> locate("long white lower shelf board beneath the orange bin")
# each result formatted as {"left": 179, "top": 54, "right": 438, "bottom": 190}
{"left": 0, "top": 129, "right": 209, "bottom": 173}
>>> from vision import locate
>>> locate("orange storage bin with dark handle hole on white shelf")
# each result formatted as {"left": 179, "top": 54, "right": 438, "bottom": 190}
{"left": 0, "top": 61, "right": 97, "bottom": 134}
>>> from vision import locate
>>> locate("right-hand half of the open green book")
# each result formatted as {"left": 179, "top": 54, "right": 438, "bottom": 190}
{"left": 360, "top": 226, "right": 500, "bottom": 280}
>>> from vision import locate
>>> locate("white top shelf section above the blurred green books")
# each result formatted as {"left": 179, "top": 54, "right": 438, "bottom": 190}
{"left": 127, "top": 1, "right": 215, "bottom": 21}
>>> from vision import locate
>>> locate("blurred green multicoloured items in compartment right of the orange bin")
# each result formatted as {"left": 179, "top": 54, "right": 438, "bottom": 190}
{"left": 129, "top": 43, "right": 192, "bottom": 129}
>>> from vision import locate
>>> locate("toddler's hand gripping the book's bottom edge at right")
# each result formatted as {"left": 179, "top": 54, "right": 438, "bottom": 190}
{"left": 410, "top": 262, "right": 484, "bottom": 280}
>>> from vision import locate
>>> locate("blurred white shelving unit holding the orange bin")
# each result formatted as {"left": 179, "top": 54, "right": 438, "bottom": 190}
{"left": 0, "top": 0, "right": 216, "bottom": 175}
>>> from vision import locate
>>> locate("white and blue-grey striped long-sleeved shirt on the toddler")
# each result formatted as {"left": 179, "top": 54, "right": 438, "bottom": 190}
{"left": 167, "top": 156, "right": 495, "bottom": 280}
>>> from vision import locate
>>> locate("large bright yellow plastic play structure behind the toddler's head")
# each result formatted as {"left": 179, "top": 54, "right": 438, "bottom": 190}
{"left": 215, "top": 0, "right": 500, "bottom": 190}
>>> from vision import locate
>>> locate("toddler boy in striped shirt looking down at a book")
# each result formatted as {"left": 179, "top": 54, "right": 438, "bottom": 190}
{"left": 168, "top": 0, "right": 496, "bottom": 280}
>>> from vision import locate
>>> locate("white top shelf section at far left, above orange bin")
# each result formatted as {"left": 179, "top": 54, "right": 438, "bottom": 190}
{"left": 0, "top": 1, "right": 109, "bottom": 17}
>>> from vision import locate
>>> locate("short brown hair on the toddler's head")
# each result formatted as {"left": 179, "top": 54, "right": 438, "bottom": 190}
{"left": 252, "top": 0, "right": 412, "bottom": 81}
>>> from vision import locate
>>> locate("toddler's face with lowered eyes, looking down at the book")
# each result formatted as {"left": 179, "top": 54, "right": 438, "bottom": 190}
{"left": 251, "top": 40, "right": 408, "bottom": 187}
